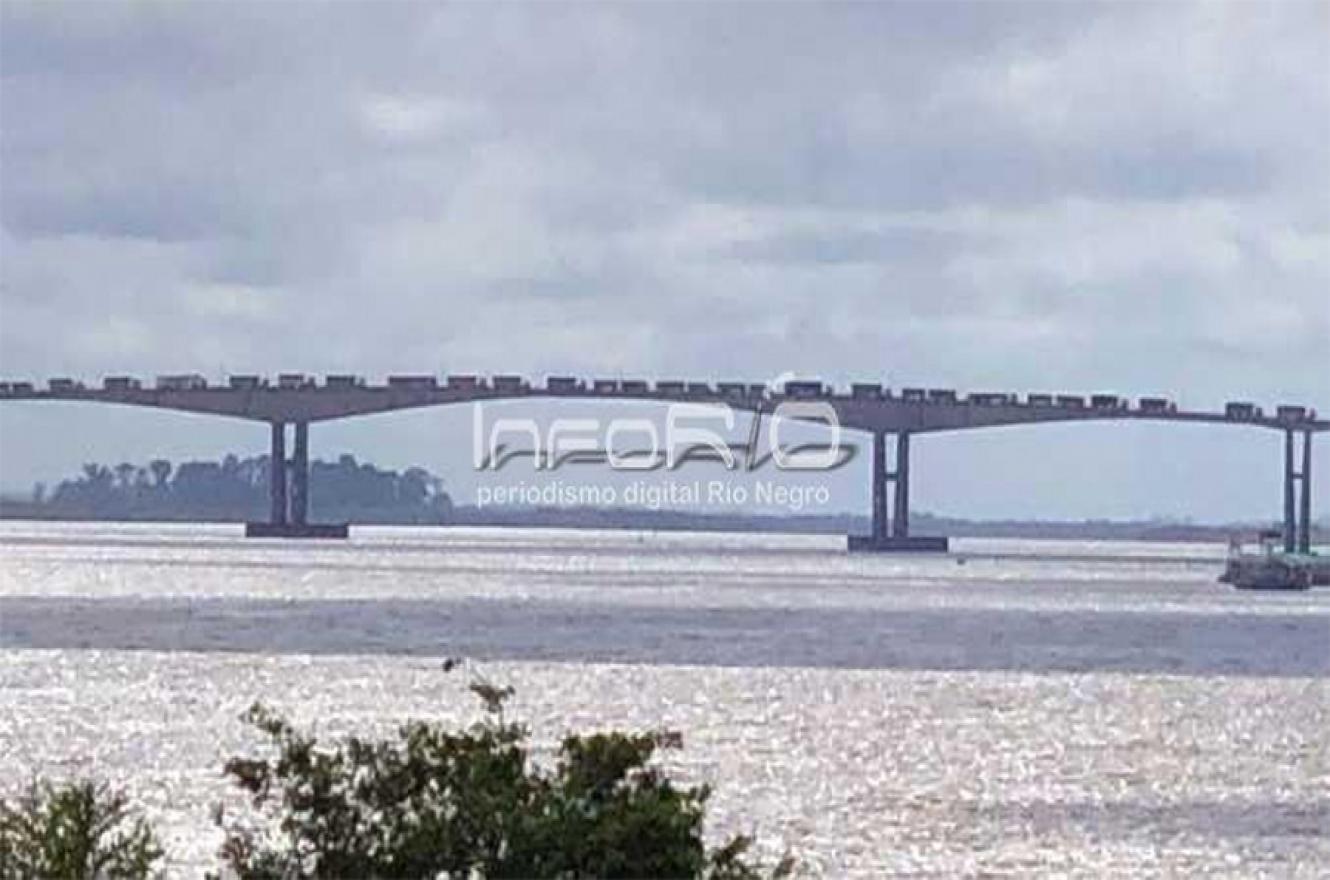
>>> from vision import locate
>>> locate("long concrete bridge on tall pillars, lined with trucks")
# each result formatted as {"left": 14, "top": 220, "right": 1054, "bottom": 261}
{"left": 0, "top": 374, "right": 1330, "bottom": 553}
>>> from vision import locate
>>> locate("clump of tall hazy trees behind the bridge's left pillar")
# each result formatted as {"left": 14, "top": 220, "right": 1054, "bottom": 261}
{"left": 25, "top": 455, "right": 452, "bottom": 524}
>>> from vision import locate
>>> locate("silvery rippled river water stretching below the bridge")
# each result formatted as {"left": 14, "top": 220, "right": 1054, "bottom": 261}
{"left": 0, "top": 522, "right": 1330, "bottom": 877}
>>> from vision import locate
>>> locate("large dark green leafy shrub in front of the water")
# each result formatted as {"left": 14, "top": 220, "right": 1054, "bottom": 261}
{"left": 219, "top": 685, "right": 789, "bottom": 880}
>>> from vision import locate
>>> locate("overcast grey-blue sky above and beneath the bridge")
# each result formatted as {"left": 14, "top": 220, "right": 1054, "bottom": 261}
{"left": 0, "top": 0, "right": 1330, "bottom": 521}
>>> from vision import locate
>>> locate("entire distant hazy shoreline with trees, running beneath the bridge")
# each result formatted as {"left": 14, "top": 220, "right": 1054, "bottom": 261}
{"left": 0, "top": 455, "right": 1330, "bottom": 544}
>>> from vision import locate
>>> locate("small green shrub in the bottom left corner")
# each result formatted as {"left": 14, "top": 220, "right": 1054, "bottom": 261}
{"left": 0, "top": 782, "right": 162, "bottom": 880}
